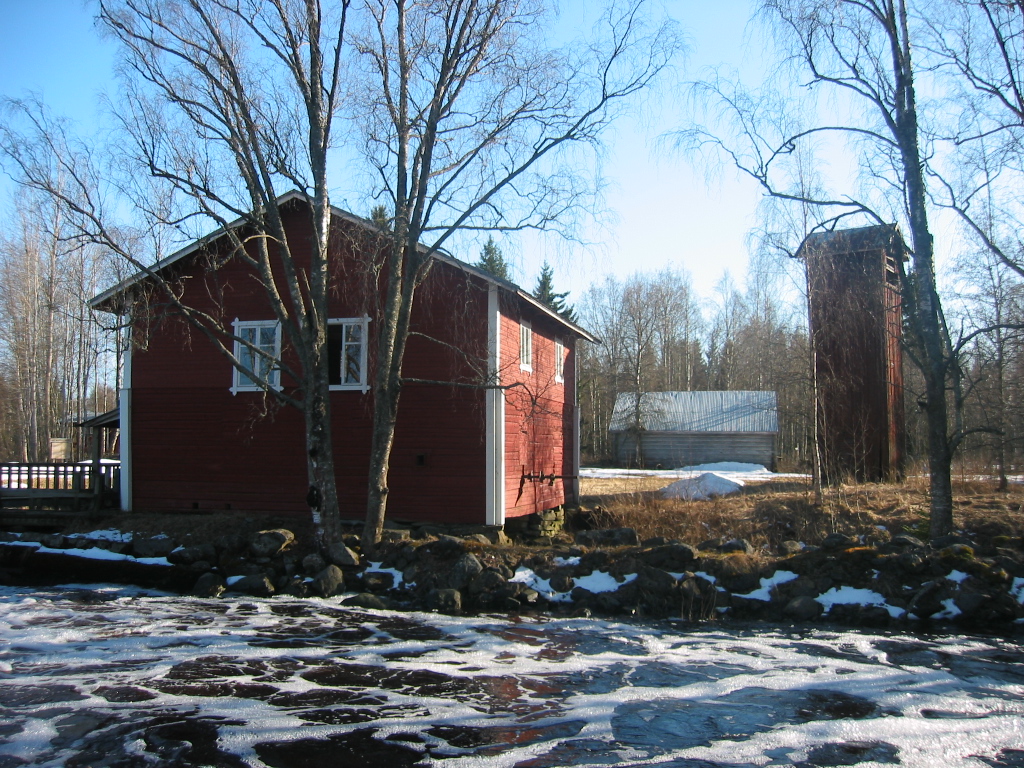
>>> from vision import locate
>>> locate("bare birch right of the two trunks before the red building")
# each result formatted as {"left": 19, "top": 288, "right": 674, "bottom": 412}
{"left": 355, "top": 0, "right": 678, "bottom": 547}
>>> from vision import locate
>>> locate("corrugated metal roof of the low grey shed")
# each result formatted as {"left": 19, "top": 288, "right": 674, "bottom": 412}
{"left": 608, "top": 391, "right": 778, "bottom": 432}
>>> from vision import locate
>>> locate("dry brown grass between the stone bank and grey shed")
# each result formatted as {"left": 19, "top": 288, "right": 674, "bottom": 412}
{"left": 581, "top": 477, "right": 1024, "bottom": 551}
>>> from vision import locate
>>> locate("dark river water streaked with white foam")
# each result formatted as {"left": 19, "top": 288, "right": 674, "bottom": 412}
{"left": 0, "top": 586, "right": 1024, "bottom": 768}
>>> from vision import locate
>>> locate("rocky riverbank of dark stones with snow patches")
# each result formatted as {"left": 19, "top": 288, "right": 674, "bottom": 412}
{"left": 0, "top": 528, "right": 1024, "bottom": 630}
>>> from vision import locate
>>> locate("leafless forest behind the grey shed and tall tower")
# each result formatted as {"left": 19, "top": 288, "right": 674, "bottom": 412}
{"left": 575, "top": 254, "right": 1024, "bottom": 477}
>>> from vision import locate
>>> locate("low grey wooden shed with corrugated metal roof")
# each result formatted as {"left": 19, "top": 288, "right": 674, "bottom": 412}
{"left": 608, "top": 391, "right": 778, "bottom": 469}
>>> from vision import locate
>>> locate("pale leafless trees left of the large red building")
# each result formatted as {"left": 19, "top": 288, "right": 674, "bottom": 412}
{"left": 0, "top": 194, "right": 118, "bottom": 461}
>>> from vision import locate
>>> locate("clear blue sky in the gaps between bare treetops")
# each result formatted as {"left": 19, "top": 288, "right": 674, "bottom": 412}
{"left": 0, "top": 0, "right": 763, "bottom": 299}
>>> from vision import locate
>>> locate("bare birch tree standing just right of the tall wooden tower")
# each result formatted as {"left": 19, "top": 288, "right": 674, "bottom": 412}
{"left": 686, "top": 0, "right": 964, "bottom": 537}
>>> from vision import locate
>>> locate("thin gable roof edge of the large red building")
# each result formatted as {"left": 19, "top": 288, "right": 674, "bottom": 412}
{"left": 89, "top": 189, "right": 598, "bottom": 342}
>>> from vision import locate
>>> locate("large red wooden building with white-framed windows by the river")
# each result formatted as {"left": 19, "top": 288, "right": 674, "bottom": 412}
{"left": 92, "top": 193, "right": 594, "bottom": 525}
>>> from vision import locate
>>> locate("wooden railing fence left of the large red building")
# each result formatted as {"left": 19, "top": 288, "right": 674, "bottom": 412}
{"left": 0, "top": 462, "right": 121, "bottom": 512}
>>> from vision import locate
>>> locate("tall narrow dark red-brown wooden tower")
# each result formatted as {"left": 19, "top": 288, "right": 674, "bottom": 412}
{"left": 797, "top": 225, "right": 906, "bottom": 482}
